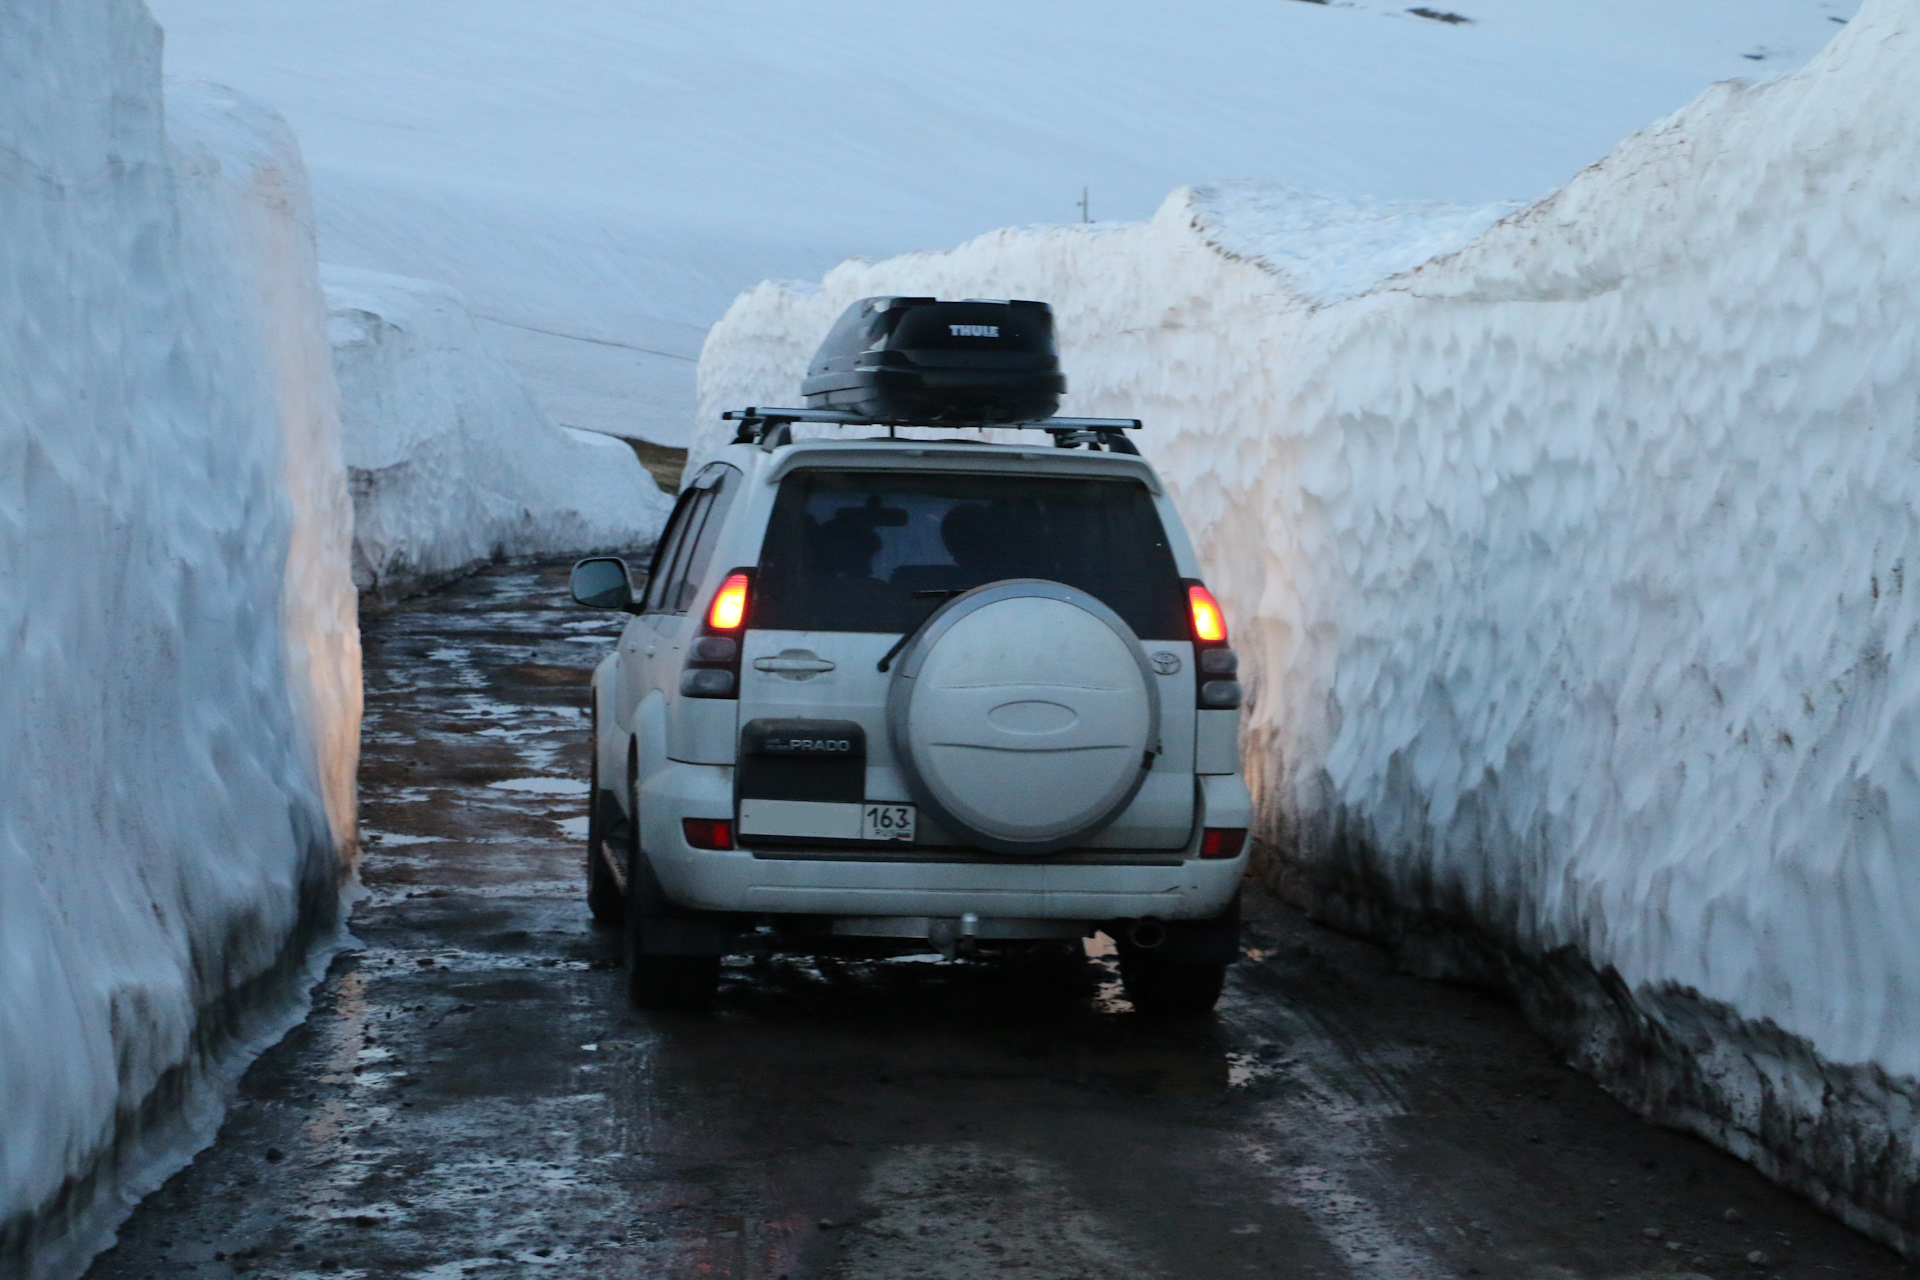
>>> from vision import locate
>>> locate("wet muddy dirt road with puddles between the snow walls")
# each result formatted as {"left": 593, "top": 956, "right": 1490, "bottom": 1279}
{"left": 90, "top": 566, "right": 1912, "bottom": 1280}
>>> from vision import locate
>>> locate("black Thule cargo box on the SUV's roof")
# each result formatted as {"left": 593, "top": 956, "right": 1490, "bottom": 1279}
{"left": 801, "top": 297, "right": 1068, "bottom": 426}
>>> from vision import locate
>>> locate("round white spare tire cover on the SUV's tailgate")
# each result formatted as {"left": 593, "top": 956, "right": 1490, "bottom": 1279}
{"left": 887, "top": 578, "right": 1160, "bottom": 854}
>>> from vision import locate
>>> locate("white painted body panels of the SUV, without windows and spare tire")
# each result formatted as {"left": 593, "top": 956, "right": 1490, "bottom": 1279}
{"left": 593, "top": 441, "right": 1252, "bottom": 921}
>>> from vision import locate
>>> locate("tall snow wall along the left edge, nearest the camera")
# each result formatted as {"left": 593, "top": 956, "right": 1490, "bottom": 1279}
{"left": 0, "top": 0, "right": 359, "bottom": 1278}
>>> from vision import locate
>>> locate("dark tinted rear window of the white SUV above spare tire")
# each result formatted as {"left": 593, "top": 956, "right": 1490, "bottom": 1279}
{"left": 753, "top": 470, "right": 1187, "bottom": 639}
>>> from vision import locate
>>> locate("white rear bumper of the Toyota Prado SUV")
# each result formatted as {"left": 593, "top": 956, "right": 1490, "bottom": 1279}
{"left": 639, "top": 764, "right": 1252, "bottom": 921}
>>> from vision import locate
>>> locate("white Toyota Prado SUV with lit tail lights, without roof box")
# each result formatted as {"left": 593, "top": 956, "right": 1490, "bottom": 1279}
{"left": 572, "top": 411, "right": 1250, "bottom": 1013}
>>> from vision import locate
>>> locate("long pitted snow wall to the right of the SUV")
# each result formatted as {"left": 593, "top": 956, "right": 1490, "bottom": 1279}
{"left": 687, "top": 0, "right": 1920, "bottom": 1255}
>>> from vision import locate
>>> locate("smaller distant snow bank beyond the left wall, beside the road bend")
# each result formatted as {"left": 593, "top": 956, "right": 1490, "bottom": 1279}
{"left": 321, "top": 267, "right": 672, "bottom": 591}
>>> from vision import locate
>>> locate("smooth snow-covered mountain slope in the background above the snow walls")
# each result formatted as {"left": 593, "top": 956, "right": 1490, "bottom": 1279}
{"left": 154, "top": 0, "right": 1853, "bottom": 443}
